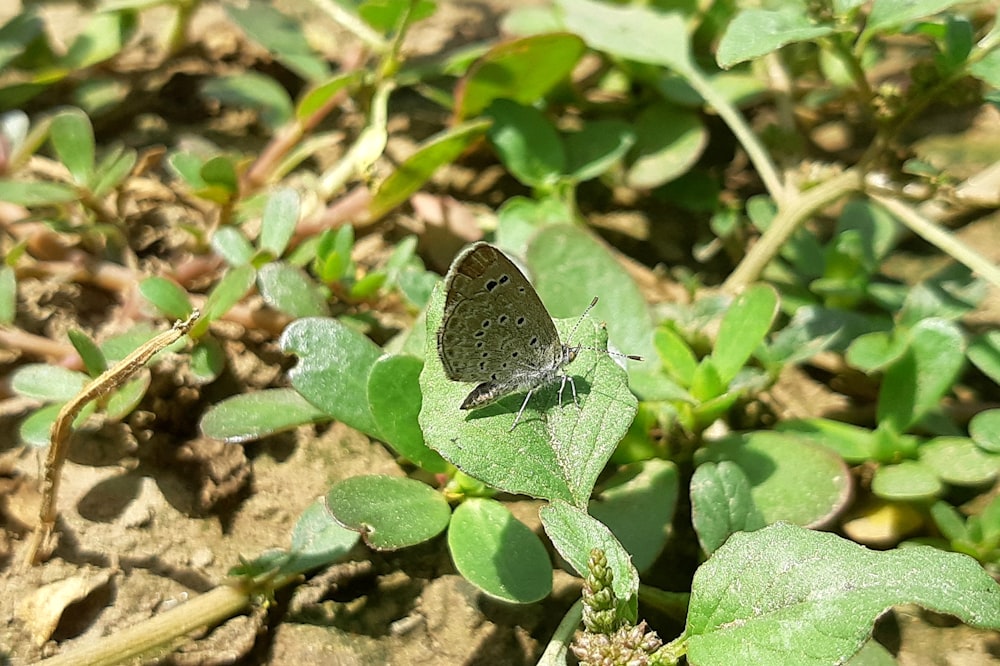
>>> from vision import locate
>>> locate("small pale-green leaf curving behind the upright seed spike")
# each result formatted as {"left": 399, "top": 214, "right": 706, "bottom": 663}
{"left": 538, "top": 501, "right": 639, "bottom": 623}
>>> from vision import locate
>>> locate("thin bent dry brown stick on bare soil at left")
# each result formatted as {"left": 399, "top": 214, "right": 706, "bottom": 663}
{"left": 24, "top": 310, "right": 199, "bottom": 566}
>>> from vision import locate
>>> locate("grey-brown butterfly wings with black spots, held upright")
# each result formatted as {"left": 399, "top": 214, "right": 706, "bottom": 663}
{"left": 437, "top": 243, "right": 564, "bottom": 409}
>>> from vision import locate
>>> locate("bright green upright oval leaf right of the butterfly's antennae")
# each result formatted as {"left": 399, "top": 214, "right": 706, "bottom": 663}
{"left": 712, "top": 284, "right": 778, "bottom": 386}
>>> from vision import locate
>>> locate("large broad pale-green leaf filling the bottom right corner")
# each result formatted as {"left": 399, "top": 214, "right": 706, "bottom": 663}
{"left": 685, "top": 525, "right": 1000, "bottom": 666}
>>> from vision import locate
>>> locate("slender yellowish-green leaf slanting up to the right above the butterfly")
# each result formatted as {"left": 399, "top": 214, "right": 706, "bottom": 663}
{"left": 369, "top": 120, "right": 489, "bottom": 219}
